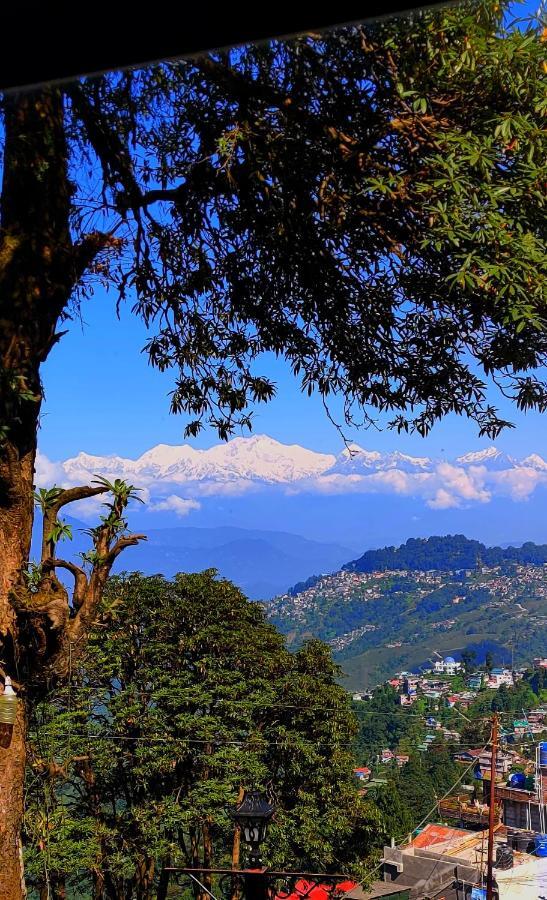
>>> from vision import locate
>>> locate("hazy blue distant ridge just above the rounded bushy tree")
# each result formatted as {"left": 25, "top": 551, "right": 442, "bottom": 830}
{"left": 34, "top": 517, "right": 351, "bottom": 600}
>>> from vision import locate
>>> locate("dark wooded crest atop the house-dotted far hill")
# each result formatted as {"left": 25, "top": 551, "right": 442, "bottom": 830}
{"left": 343, "top": 534, "right": 547, "bottom": 572}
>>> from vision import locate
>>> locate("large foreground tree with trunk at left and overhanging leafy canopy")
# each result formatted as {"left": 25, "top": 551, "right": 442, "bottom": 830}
{"left": 0, "top": 0, "right": 547, "bottom": 884}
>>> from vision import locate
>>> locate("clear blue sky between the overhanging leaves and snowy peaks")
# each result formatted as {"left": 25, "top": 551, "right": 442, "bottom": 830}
{"left": 39, "top": 0, "right": 547, "bottom": 460}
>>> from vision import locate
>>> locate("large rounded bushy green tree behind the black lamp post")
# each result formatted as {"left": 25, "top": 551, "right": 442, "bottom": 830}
{"left": 26, "top": 571, "right": 381, "bottom": 900}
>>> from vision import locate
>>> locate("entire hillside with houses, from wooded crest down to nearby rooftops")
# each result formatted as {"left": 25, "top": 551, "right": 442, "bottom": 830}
{"left": 267, "top": 535, "right": 547, "bottom": 900}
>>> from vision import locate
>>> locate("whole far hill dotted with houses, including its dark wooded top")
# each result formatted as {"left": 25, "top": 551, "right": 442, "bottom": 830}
{"left": 268, "top": 535, "right": 547, "bottom": 688}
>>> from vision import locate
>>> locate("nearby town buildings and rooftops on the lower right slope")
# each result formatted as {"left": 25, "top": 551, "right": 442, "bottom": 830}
{"left": 352, "top": 656, "right": 547, "bottom": 900}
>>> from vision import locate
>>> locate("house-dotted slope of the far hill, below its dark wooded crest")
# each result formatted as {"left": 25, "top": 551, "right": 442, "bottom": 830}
{"left": 266, "top": 558, "right": 547, "bottom": 680}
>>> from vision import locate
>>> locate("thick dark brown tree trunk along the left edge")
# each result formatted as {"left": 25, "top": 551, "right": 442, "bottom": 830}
{"left": 0, "top": 89, "right": 75, "bottom": 900}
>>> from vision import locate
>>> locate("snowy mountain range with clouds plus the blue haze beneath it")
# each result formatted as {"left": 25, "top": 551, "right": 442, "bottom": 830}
{"left": 36, "top": 435, "right": 547, "bottom": 552}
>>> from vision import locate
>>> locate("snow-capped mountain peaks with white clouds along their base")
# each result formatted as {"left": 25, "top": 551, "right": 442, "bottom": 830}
{"left": 40, "top": 435, "right": 547, "bottom": 517}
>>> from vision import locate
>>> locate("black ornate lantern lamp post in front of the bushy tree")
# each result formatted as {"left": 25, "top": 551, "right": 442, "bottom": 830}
{"left": 232, "top": 791, "right": 275, "bottom": 900}
